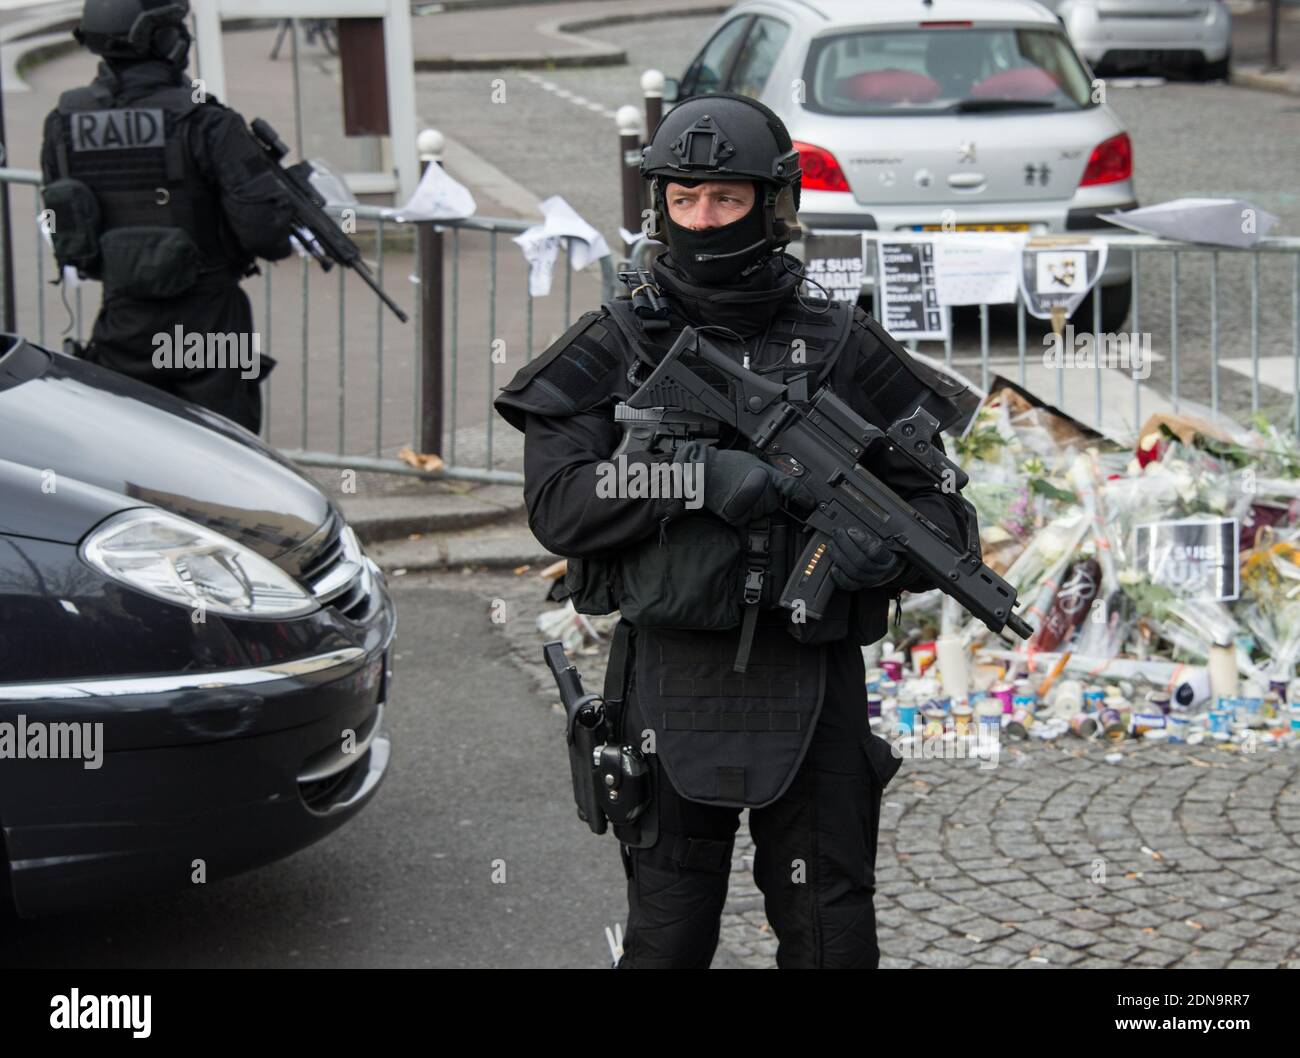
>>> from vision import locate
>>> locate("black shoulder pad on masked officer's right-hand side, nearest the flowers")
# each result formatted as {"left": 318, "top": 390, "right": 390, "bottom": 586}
{"left": 853, "top": 307, "right": 967, "bottom": 429}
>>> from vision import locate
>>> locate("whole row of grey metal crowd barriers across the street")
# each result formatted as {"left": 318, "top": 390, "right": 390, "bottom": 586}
{"left": 0, "top": 160, "right": 1300, "bottom": 462}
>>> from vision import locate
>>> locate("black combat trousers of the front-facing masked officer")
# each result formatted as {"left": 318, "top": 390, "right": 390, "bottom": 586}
{"left": 619, "top": 642, "right": 897, "bottom": 970}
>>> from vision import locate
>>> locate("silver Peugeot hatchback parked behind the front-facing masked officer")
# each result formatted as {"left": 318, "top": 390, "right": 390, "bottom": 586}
{"left": 666, "top": 0, "right": 1136, "bottom": 331}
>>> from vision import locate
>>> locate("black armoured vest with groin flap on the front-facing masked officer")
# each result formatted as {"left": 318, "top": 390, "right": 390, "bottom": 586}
{"left": 497, "top": 275, "right": 967, "bottom": 807}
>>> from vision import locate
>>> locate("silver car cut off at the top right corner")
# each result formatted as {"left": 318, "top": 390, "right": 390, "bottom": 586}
{"left": 1048, "top": 0, "right": 1232, "bottom": 81}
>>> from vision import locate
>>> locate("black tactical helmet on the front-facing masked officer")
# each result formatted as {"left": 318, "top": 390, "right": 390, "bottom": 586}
{"left": 641, "top": 92, "right": 803, "bottom": 250}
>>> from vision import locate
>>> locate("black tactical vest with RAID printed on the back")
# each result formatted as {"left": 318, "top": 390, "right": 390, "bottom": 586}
{"left": 43, "top": 84, "right": 239, "bottom": 299}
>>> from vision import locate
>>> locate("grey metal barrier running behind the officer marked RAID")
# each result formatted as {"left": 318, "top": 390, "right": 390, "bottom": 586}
{"left": 0, "top": 169, "right": 615, "bottom": 484}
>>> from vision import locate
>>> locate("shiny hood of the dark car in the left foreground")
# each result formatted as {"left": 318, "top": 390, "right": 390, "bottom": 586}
{"left": 0, "top": 335, "right": 330, "bottom": 559}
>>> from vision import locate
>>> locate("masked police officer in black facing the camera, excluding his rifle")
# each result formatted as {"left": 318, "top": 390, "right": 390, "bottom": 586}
{"left": 495, "top": 95, "right": 976, "bottom": 968}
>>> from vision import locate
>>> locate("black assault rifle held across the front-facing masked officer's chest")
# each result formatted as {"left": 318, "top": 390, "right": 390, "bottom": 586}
{"left": 614, "top": 328, "right": 1034, "bottom": 639}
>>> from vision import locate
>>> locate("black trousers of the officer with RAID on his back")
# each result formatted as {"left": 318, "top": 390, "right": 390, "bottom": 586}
{"left": 86, "top": 277, "right": 276, "bottom": 433}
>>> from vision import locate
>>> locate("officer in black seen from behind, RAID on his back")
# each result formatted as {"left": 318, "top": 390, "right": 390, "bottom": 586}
{"left": 40, "top": 0, "right": 294, "bottom": 432}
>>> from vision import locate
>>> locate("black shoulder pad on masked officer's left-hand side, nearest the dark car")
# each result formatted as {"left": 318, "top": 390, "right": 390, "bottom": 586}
{"left": 493, "top": 308, "right": 627, "bottom": 430}
